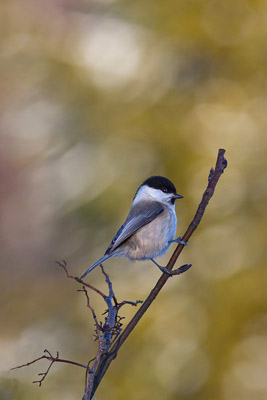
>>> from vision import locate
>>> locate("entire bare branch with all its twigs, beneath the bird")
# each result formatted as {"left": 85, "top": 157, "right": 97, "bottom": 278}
{"left": 12, "top": 149, "right": 227, "bottom": 400}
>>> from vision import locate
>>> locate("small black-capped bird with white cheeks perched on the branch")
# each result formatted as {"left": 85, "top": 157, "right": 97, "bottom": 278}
{"left": 81, "top": 176, "right": 187, "bottom": 279}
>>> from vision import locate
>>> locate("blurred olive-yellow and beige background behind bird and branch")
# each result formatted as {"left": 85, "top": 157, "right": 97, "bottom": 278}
{"left": 0, "top": 0, "right": 267, "bottom": 400}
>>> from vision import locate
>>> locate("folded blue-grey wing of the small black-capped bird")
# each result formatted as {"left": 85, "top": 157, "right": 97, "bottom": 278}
{"left": 105, "top": 202, "right": 164, "bottom": 254}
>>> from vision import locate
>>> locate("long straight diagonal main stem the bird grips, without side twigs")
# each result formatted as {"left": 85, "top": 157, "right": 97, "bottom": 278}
{"left": 90, "top": 149, "right": 227, "bottom": 398}
